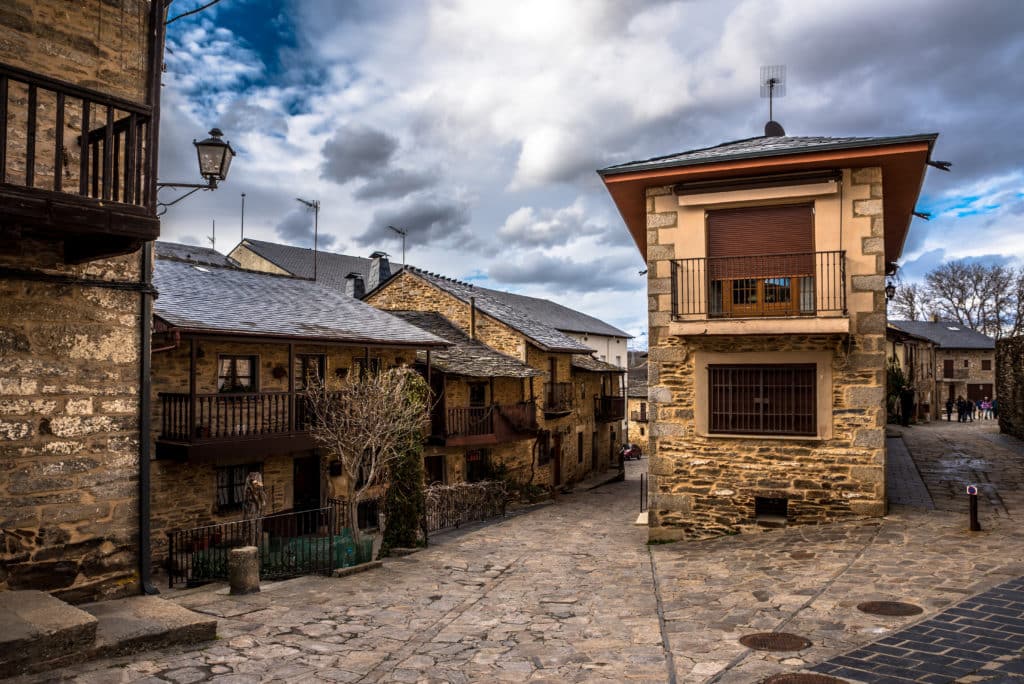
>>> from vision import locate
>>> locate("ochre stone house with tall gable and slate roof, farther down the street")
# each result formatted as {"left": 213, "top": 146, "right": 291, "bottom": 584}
{"left": 366, "top": 267, "right": 625, "bottom": 486}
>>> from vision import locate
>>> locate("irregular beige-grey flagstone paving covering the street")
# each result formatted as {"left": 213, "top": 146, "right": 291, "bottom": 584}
{"left": 14, "top": 423, "right": 1024, "bottom": 684}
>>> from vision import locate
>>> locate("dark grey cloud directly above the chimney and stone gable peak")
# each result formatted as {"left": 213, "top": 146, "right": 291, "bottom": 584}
{"left": 355, "top": 199, "right": 473, "bottom": 249}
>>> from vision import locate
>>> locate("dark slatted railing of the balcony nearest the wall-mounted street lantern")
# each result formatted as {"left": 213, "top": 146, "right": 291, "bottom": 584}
{"left": 0, "top": 63, "right": 154, "bottom": 207}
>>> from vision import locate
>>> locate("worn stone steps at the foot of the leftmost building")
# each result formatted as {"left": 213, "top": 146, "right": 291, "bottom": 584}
{"left": 0, "top": 591, "right": 217, "bottom": 678}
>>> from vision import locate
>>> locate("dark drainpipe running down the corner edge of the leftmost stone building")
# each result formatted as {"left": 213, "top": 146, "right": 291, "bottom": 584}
{"left": 138, "top": 0, "right": 168, "bottom": 595}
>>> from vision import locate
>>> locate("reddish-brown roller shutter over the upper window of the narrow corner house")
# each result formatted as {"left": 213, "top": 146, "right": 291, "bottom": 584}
{"left": 707, "top": 204, "right": 814, "bottom": 280}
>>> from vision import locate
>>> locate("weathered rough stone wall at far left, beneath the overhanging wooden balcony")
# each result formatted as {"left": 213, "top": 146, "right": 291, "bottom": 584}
{"left": 0, "top": 241, "right": 140, "bottom": 601}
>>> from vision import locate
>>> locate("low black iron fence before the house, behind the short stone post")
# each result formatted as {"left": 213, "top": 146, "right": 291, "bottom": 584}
{"left": 167, "top": 500, "right": 373, "bottom": 587}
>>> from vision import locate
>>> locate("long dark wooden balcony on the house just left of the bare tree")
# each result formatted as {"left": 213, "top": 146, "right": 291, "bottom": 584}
{"left": 157, "top": 392, "right": 337, "bottom": 461}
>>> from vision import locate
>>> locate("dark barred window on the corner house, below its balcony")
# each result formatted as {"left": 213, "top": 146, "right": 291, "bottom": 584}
{"left": 708, "top": 364, "right": 817, "bottom": 435}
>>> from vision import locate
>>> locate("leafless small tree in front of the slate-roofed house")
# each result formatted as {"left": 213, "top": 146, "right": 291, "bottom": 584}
{"left": 305, "top": 368, "right": 430, "bottom": 548}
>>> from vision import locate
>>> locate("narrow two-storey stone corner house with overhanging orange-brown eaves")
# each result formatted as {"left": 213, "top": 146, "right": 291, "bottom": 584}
{"left": 599, "top": 122, "right": 937, "bottom": 540}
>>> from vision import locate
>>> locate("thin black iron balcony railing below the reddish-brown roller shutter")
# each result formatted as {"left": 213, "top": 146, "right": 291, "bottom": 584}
{"left": 671, "top": 250, "right": 847, "bottom": 320}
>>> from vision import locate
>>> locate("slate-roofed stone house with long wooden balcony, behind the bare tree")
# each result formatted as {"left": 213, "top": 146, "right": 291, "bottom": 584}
{"left": 152, "top": 243, "right": 449, "bottom": 561}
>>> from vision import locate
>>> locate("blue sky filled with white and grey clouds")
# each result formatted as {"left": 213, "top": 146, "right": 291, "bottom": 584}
{"left": 160, "top": 0, "right": 1024, "bottom": 348}
